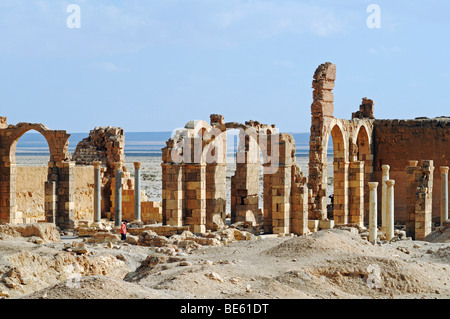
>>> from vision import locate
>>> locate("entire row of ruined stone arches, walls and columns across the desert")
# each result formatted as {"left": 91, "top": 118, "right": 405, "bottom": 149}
{"left": 0, "top": 62, "right": 450, "bottom": 239}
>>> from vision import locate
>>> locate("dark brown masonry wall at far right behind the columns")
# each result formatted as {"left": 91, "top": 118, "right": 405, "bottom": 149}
{"left": 373, "top": 117, "right": 450, "bottom": 221}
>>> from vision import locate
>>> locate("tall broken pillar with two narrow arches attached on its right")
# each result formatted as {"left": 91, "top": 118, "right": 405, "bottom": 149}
{"left": 308, "top": 63, "right": 374, "bottom": 226}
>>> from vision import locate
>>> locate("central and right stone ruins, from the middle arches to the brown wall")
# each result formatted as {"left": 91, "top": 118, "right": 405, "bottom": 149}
{"left": 162, "top": 62, "right": 450, "bottom": 239}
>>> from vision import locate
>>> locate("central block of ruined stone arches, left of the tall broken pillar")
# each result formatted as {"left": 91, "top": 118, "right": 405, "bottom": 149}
{"left": 162, "top": 114, "right": 307, "bottom": 234}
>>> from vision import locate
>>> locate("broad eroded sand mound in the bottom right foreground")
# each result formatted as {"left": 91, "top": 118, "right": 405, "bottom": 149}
{"left": 275, "top": 256, "right": 449, "bottom": 298}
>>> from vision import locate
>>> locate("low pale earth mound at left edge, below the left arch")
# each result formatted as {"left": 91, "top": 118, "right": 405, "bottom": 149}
{"left": 0, "top": 223, "right": 61, "bottom": 242}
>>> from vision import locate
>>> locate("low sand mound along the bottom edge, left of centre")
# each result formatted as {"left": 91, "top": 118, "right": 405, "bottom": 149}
{"left": 23, "top": 276, "right": 176, "bottom": 299}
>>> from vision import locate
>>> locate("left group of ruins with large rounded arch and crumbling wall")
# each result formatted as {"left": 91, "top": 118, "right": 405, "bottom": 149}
{"left": 0, "top": 123, "right": 161, "bottom": 230}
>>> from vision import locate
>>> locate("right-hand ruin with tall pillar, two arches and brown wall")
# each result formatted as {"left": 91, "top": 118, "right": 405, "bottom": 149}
{"left": 308, "top": 63, "right": 450, "bottom": 239}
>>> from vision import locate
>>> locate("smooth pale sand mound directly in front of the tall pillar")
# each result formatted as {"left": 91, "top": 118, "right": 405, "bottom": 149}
{"left": 263, "top": 229, "right": 374, "bottom": 257}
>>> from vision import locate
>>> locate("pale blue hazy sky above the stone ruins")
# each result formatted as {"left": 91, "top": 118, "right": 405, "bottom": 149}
{"left": 0, "top": 0, "right": 450, "bottom": 133}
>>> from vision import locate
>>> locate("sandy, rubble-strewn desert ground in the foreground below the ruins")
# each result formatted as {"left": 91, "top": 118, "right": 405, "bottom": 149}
{"left": 0, "top": 229, "right": 450, "bottom": 299}
